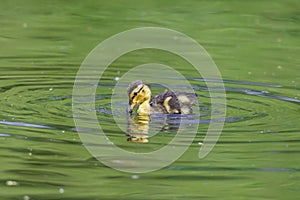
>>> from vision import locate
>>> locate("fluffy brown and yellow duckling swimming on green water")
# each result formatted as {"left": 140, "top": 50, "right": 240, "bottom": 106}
{"left": 127, "top": 80, "right": 198, "bottom": 115}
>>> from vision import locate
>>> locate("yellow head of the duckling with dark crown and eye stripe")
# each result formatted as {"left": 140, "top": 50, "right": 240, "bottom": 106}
{"left": 127, "top": 80, "right": 151, "bottom": 113}
